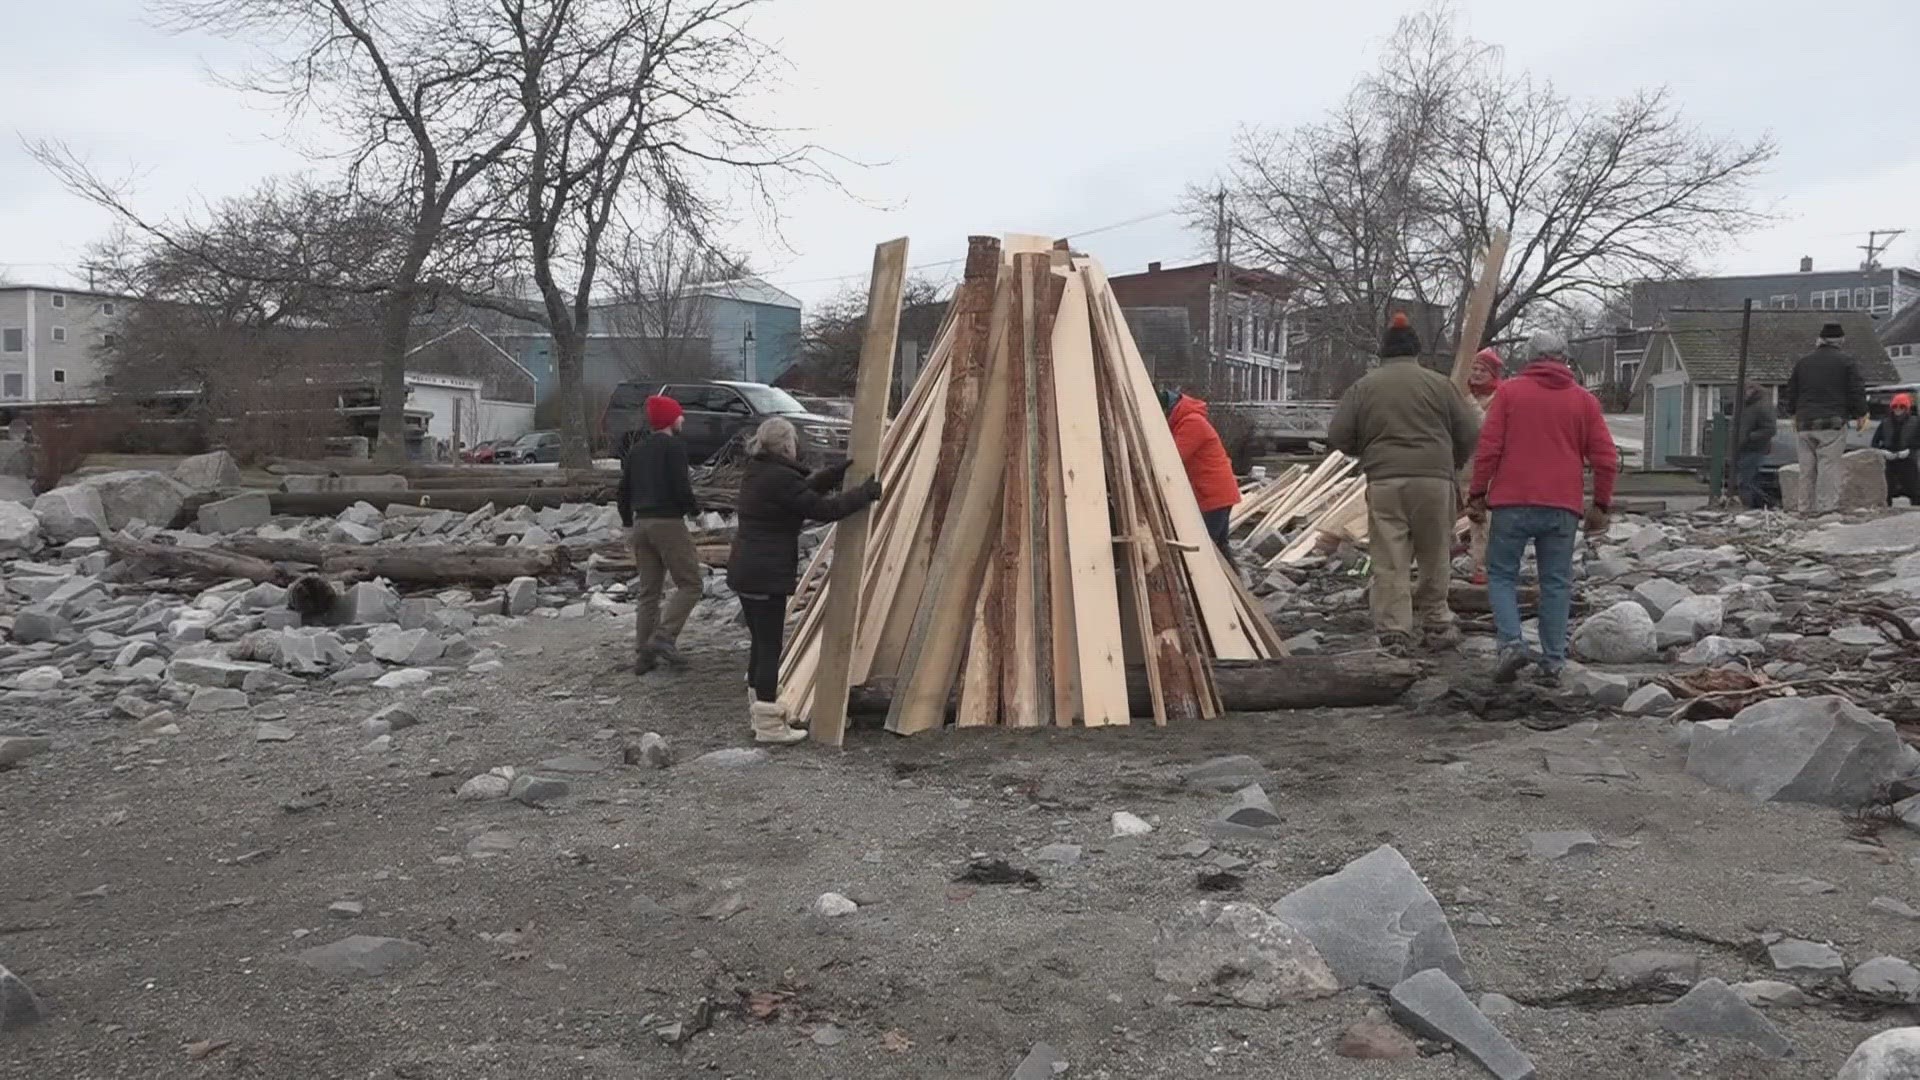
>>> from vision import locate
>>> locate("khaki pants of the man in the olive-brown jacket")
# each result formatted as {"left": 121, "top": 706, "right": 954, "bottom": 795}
{"left": 1367, "top": 477, "right": 1457, "bottom": 634}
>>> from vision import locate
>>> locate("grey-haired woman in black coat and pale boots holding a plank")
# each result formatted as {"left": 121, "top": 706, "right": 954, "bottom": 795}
{"left": 726, "top": 417, "right": 879, "bottom": 744}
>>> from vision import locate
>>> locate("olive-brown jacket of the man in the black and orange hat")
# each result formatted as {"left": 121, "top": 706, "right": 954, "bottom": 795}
{"left": 1327, "top": 359, "right": 1480, "bottom": 480}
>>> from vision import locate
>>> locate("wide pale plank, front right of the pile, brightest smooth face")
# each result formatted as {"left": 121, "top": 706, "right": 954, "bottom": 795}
{"left": 1052, "top": 273, "right": 1127, "bottom": 726}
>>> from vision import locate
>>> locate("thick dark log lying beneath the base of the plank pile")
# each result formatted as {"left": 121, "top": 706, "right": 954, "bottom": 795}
{"left": 847, "top": 653, "right": 1419, "bottom": 717}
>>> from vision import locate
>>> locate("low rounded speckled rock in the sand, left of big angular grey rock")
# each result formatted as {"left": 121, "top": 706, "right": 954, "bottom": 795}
{"left": 1154, "top": 901, "right": 1340, "bottom": 1009}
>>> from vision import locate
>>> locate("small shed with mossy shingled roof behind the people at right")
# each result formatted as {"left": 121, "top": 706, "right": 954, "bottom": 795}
{"left": 1634, "top": 307, "right": 1897, "bottom": 469}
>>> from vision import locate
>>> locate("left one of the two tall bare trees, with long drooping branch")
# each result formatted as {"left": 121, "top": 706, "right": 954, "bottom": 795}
{"left": 33, "top": 0, "right": 541, "bottom": 461}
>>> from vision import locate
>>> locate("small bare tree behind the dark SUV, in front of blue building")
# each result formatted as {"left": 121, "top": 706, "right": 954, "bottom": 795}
{"left": 599, "top": 225, "right": 747, "bottom": 382}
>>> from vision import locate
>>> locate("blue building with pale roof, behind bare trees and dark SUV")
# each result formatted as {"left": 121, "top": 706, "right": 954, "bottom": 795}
{"left": 492, "top": 277, "right": 801, "bottom": 402}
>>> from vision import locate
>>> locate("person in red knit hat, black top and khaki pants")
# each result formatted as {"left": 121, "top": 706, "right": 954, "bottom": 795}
{"left": 616, "top": 394, "right": 701, "bottom": 675}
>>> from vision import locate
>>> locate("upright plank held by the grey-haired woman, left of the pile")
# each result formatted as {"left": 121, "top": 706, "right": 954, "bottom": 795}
{"left": 808, "top": 236, "right": 906, "bottom": 746}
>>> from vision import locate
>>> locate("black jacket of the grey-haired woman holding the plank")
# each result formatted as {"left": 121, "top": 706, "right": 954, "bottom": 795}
{"left": 726, "top": 454, "right": 874, "bottom": 596}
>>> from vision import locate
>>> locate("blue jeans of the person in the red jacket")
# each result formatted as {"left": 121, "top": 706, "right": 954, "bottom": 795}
{"left": 1486, "top": 505, "right": 1580, "bottom": 671}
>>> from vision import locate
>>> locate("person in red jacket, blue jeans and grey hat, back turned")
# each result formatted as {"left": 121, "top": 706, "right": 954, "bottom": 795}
{"left": 1467, "top": 332, "right": 1620, "bottom": 684}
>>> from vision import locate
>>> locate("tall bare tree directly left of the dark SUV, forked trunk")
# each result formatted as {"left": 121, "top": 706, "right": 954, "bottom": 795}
{"left": 462, "top": 0, "right": 831, "bottom": 467}
